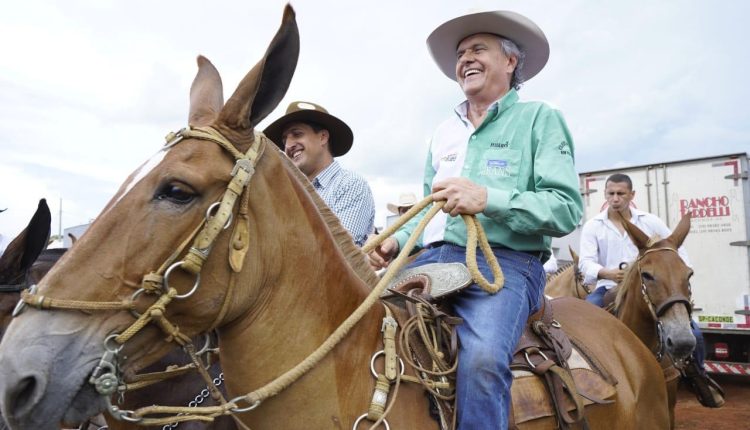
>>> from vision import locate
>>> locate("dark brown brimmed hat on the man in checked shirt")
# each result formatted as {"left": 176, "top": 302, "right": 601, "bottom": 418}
{"left": 263, "top": 101, "right": 354, "bottom": 157}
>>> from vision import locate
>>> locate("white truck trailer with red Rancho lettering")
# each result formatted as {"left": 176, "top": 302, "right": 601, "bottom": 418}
{"left": 553, "top": 153, "right": 750, "bottom": 375}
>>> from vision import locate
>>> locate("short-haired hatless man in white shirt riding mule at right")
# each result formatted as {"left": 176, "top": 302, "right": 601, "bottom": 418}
{"left": 578, "top": 173, "right": 724, "bottom": 408}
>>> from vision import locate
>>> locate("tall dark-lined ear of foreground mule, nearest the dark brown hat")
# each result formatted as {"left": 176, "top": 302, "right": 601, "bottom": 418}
{"left": 219, "top": 4, "right": 299, "bottom": 131}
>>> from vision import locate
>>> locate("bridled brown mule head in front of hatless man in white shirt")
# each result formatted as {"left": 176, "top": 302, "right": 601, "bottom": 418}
{"left": 623, "top": 214, "right": 695, "bottom": 360}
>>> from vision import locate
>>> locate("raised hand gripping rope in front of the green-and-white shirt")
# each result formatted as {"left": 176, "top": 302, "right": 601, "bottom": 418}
{"left": 432, "top": 178, "right": 487, "bottom": 216}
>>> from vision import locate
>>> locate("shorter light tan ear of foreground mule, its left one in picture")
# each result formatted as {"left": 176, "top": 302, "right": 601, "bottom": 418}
{"left": 188, "top": 55, "right": 224, "bottom": 126}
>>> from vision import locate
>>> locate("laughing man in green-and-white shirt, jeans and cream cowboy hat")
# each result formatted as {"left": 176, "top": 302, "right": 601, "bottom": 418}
{"left": 370, "top": 11, "right": 582, "bottom": 430}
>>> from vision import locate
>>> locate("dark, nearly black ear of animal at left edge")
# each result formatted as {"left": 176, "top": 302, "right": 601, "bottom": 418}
{"left": 0, "top": 199, "right": 52, "bottom": 282}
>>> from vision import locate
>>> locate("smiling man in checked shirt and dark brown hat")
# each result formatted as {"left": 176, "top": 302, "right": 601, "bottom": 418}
{"left": 263, "top": 101, "right": 375, "bottom": 246}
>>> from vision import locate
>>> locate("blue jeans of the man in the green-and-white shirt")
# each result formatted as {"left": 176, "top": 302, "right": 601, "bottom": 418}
{"left": 410, "top": 244, "right": 545, "bottom": 430}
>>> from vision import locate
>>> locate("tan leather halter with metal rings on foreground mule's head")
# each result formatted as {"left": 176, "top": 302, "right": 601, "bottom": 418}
{"left": 14, "top": 126, "right": 268, "bottom": 422}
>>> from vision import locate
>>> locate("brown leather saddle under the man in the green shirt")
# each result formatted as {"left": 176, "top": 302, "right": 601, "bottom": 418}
{"left": 381, "top": 263, "right": 617, "bottom": 429}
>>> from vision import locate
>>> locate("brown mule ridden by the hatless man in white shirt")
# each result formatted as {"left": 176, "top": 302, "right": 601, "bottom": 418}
{"left": 614, "top": 214, "right": 696, "bottom": 428}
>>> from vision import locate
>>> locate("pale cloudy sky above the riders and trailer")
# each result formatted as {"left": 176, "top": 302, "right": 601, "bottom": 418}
{"left": 0, "top": 0, "right": 750, "bottom": 242}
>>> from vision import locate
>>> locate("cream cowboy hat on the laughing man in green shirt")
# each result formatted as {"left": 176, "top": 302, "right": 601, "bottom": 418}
{"left": 427, "top": 10, "right": 549, "bottom": 81}
